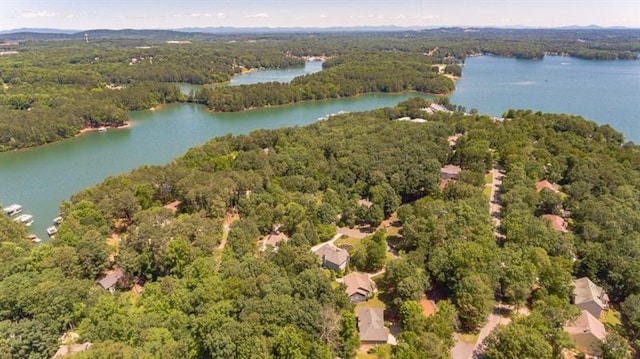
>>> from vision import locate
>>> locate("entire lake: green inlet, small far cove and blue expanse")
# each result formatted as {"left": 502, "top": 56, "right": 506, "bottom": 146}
{"left": 0, "top": 57, "right": 640, "bottom": 239}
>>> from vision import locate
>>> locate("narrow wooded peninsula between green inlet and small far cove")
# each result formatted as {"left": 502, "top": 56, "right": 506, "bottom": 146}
{"left": 195, "top": 53, "right": 455, "bottom": 112}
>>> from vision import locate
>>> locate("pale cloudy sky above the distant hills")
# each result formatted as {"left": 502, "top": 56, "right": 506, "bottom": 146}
{"left": 0, "top": 0, "right": 640, "bottom": 30}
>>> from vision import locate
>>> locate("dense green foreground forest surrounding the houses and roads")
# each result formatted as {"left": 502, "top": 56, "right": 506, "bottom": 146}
{"left": 0, "top": 97, "right": 640, "bottom": 359}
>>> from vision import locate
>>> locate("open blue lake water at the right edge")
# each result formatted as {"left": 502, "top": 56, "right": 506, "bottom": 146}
{"left": 450, "top": 56, "right": 640, "bottom": 143}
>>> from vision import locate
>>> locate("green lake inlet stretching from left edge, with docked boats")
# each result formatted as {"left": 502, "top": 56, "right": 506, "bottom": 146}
{"left": 0, "top": 94, "right": 426, "bottom": 239}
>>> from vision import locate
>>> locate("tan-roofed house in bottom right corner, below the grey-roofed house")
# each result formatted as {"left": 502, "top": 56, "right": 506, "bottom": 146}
{"left": 564, "top": 310, "right": 607, "bottom": 355}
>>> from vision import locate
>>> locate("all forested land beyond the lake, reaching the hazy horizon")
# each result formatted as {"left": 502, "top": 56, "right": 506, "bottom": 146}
{"left": 0, "top": 28, "right": 640, "bottom": 151}
